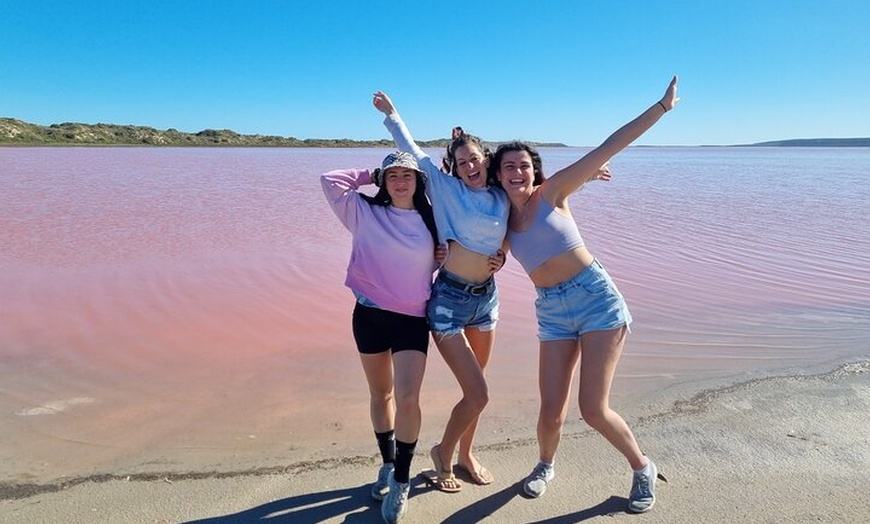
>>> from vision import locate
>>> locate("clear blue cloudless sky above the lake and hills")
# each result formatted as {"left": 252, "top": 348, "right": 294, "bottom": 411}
{"left": 0, "top": 0, "right": 870, "bottom": 146}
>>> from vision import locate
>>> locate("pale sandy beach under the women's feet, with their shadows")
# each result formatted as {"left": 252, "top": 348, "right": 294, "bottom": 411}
{"left": 0, "top": 360, "right": 870, "bottom": 524}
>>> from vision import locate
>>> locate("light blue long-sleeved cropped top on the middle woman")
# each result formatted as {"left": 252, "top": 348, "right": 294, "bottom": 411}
{"left": 384, "top": 113, "right": 510, "bottom": 256}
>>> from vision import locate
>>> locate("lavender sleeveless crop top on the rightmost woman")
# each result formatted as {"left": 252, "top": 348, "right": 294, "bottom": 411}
{"left": 507, "top": 198, "right": 584, "bottom": 275}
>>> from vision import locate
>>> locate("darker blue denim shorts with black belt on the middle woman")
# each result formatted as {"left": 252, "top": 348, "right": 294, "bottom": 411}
{"left": 426, "top": 269, "right": 498, "bottom": 337}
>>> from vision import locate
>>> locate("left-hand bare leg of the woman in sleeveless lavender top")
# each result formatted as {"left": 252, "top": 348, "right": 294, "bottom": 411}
{"left": 538, "top": 340, "right": 580, "bottom": 464}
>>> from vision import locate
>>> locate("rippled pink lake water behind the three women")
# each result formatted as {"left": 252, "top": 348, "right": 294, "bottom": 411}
{"left": 0, "top": 148, "right": 870, "bottom": 484}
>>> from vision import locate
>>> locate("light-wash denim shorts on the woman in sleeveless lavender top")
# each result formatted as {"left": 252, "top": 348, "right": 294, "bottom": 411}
{"left": 535, "top": 260, "right": 631, "bottom": 341}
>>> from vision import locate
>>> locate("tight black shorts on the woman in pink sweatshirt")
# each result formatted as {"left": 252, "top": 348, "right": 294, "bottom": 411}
{"left": 353, "top": 302, "right": 429, "bottom": 354}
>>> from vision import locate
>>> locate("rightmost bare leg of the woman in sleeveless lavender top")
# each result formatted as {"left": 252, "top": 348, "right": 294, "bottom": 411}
{"left": 578, "top": 327, "right": 647, "bottom": 469}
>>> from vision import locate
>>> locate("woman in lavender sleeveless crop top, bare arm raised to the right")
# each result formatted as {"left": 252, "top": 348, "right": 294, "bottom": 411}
{"left": 493, "top": 77, "right": 678, "bottom": 513}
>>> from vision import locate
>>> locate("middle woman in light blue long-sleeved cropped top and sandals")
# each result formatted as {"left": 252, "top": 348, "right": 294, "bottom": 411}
{"left": 373, "top": 92, "right": 509, "bottom": 492}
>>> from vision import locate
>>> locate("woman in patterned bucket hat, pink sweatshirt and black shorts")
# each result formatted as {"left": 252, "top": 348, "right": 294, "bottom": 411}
{"left": 320, "top": 151, "right": 443, "bottom": 523}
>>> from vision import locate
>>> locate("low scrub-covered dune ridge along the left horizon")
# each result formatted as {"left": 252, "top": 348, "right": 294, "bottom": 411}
{"left": 0, "top": 118, "right": 565, "bottom": 148}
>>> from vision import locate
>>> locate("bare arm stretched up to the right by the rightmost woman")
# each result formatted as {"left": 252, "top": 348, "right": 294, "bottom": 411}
{"left": 541, "top": 76, "right": 679, "bottom": 205}
